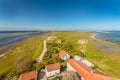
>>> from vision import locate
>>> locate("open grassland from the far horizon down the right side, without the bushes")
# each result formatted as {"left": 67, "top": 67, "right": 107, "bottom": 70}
{"left": 43, "top": 32, "right": 120, "bottom": 78}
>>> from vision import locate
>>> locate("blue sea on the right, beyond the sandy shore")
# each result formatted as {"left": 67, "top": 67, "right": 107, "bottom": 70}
{"left": 95, "top": 31, "right": 120, "bottom": 44}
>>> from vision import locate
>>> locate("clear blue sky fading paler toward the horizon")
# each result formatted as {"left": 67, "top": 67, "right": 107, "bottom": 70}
{"left": 0, "top": 0, "right": 120, "bottom": 30}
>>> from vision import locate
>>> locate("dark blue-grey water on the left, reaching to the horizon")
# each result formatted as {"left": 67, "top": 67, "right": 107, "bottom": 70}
{"left": 0, "top": 31, "right": 45, "bottom": 47}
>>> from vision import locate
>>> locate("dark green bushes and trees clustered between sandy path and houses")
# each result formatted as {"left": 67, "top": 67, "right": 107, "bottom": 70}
{"left": 42, "top": 32, "right": 86, "bottom": 68}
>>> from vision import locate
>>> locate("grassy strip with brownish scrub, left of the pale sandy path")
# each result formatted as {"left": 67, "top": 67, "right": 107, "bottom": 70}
{"left": 0, "top": 36, "right": 44, "bottom": 80}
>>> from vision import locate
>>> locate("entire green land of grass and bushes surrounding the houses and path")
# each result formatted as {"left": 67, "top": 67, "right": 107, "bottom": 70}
{"left": 0, "top": 31, "right": 120, "bottom": 78}
